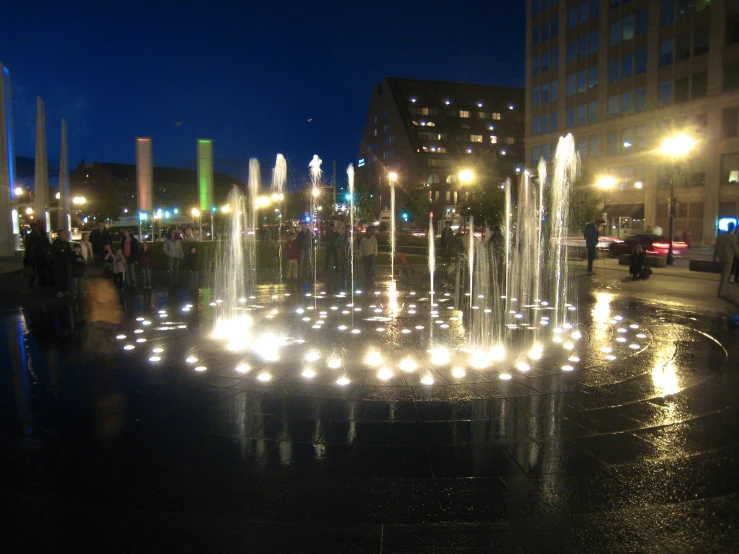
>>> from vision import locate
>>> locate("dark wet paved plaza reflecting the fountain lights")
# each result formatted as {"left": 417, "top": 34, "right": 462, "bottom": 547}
{"left": 0, "top": 266, "right": 739, "bottom": 552}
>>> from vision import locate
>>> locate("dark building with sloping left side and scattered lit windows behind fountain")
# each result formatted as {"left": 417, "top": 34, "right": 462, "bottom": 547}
{"left": 356, "top": 78, "right": 524, "bottom": 220}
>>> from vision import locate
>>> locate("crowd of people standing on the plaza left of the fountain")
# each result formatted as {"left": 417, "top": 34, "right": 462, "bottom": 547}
{"left": 24, "top": 222, "right": 199, "bottom": 298}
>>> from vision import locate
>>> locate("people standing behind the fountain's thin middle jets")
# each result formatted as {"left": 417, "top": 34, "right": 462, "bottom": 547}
{"left": 285, "top": 223, "right": 378, "bottom": 281}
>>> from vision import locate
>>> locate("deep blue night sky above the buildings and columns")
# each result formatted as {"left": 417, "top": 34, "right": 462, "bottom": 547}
{"left": 0, "top": 0, "right": 525, "bottom": 182}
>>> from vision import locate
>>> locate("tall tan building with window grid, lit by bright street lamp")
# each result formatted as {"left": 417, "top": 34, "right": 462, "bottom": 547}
{"left": 526, "top": 0, "right": 739, "bottom": 245}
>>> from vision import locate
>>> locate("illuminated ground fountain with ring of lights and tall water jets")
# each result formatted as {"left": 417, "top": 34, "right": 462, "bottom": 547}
{"left": 121, "top": 136, "right": 632, "bottom": 386}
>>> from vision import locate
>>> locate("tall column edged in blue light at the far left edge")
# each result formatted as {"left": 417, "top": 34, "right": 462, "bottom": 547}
{"left": 0, "top": 63, "right": 20, "bottom": 256}
